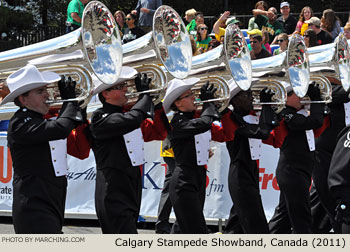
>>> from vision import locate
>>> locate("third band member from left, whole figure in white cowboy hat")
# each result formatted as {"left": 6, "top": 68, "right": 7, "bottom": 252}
{"left": 163, "top": 78, "right": 227, "bottom": 234}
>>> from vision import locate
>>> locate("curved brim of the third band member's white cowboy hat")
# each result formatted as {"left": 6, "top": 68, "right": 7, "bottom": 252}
{"left": 163, "top": 78, "right": 200, "bottom": 114}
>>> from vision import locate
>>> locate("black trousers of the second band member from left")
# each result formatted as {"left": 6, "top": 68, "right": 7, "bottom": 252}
{"left": 95, "top": 167, "right": 142, "bottom": 234}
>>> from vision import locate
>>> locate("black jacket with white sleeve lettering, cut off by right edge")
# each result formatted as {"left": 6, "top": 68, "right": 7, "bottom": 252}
{"left": 328, "top": 126, "right": 350, "bottom": 201}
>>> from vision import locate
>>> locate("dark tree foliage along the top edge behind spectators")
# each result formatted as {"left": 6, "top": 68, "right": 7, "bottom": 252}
{"left": 0, "top": 0, "right": 350, "bottom": 29}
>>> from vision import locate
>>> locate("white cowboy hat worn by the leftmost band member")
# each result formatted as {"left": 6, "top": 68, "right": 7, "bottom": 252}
{"left": 1, "top": 65, "right": 61, "bottom": 105}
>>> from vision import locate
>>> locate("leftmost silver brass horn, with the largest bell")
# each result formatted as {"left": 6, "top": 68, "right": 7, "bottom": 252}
{"left": 0, "top": 1, "right": 122, "bottom": 120}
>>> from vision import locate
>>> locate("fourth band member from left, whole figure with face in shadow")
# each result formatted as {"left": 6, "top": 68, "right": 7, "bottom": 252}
{"left": 222, "top": 83, "right": 277, "bottom": 234}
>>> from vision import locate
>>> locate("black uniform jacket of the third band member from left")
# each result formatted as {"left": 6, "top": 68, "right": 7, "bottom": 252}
{"left": 170, "top": 103, "right": 220, "bottom": 169}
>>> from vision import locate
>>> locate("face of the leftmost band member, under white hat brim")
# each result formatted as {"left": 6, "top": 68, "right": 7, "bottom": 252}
{"left": 19, "top": 86, "right": 50, "bottom": 115}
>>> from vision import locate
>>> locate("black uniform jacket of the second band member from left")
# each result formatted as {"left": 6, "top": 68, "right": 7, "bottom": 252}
{"left": 90, "top": 95, "right": 165, "bottom": 176}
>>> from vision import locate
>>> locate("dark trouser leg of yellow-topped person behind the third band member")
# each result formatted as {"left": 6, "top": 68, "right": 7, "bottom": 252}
{"left": 156, "top": 157, "right": 175, "bottom": 233}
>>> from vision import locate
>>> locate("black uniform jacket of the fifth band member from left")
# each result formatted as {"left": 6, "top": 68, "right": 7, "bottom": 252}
{"left": 276, "top": 103, "right": 324, "bottom": 170}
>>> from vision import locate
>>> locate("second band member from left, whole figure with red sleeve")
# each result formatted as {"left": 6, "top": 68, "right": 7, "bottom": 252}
{"left": 90, "top": 67, "right": 168, "bottom": 233}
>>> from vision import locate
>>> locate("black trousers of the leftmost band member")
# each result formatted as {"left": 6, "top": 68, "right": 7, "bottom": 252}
{"left": 12, "top": 175, "right": 67, "bottom": 234}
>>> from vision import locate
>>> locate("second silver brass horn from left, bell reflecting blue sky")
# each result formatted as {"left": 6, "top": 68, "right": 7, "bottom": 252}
{"left": 122, "top": 5, "right": 192, "bottom": 104}
